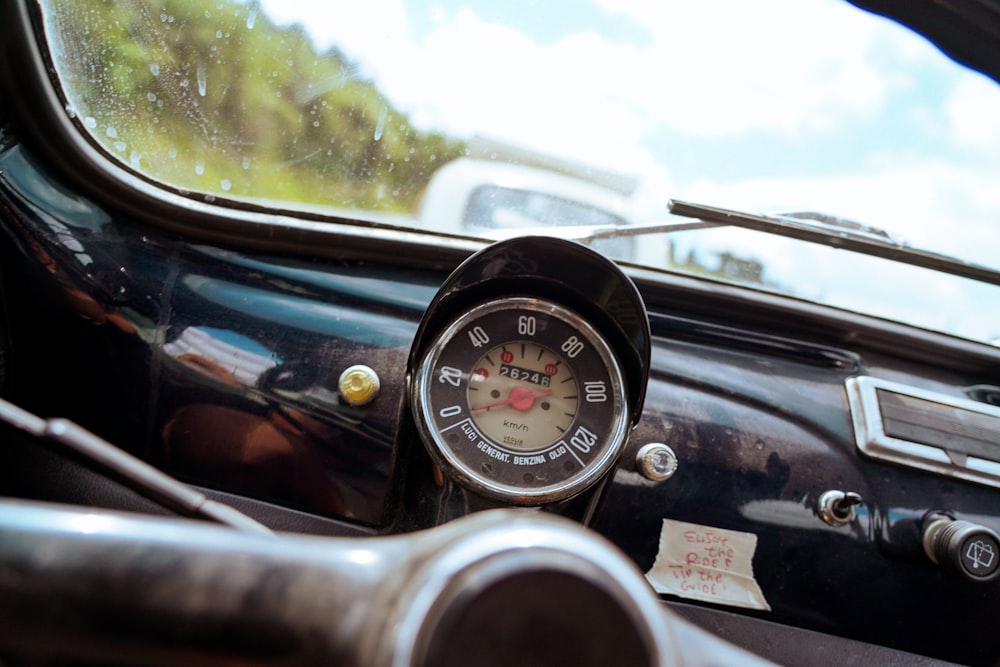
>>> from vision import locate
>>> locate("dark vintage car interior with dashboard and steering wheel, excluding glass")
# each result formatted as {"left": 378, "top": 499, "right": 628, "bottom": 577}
{"left": 0, "top": 0, "right": 1000, "bottom": 667}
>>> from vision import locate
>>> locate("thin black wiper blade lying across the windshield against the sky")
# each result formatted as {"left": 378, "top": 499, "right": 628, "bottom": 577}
{"left": 667, "top": 199, "right": 1000, "bottom": 285}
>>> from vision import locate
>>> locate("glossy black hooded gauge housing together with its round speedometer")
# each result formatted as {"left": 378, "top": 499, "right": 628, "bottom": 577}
{"left": 408, "top": 237, "right": 650, "bottom": 505}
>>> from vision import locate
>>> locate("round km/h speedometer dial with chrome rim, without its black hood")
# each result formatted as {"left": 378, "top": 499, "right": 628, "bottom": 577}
{"left": 413, "top": 298, "right": 627, "bottom": 505}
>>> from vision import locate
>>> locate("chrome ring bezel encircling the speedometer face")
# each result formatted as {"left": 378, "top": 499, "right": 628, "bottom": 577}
{"left": 411, "top": 297, "right": 628, "bottom": 505}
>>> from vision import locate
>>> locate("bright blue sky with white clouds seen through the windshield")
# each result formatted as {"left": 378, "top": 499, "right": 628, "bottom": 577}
{"left": 263, "top": 0, "right": 1000, "bottom": 337}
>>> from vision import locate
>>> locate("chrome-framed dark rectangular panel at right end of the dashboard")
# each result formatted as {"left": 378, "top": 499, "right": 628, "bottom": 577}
{"left": 847, "top": 377, "right": 1000, "bottom": 487}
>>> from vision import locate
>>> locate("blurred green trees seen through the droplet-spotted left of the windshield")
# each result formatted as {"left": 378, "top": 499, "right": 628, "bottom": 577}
{"left": 47, "top": 0, "right": 465, "bottom": 213}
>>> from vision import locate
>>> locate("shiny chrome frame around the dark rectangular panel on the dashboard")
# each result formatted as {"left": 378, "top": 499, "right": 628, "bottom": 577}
{"left": 846, "top": 376, "right": 1000, "bottom": 488}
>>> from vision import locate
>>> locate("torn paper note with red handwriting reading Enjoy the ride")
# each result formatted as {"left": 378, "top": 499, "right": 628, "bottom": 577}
{"left": 646, "top": 519, "right": 771, "bottom": 611}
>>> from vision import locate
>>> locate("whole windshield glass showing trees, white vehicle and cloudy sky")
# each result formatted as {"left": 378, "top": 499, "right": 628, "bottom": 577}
{"left": 35, "top": 0, "right": 1000, "bottom": 342}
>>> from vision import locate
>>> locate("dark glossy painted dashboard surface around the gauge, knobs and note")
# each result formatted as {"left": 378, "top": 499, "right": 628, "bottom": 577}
{"left": 0, "top": 117, "right": 1000, "bottom": 664}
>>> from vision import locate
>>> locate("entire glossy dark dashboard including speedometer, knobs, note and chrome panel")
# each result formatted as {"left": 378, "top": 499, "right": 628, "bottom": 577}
{"left": 0, "top": 132, "right": 1000, "bottom": 664}
